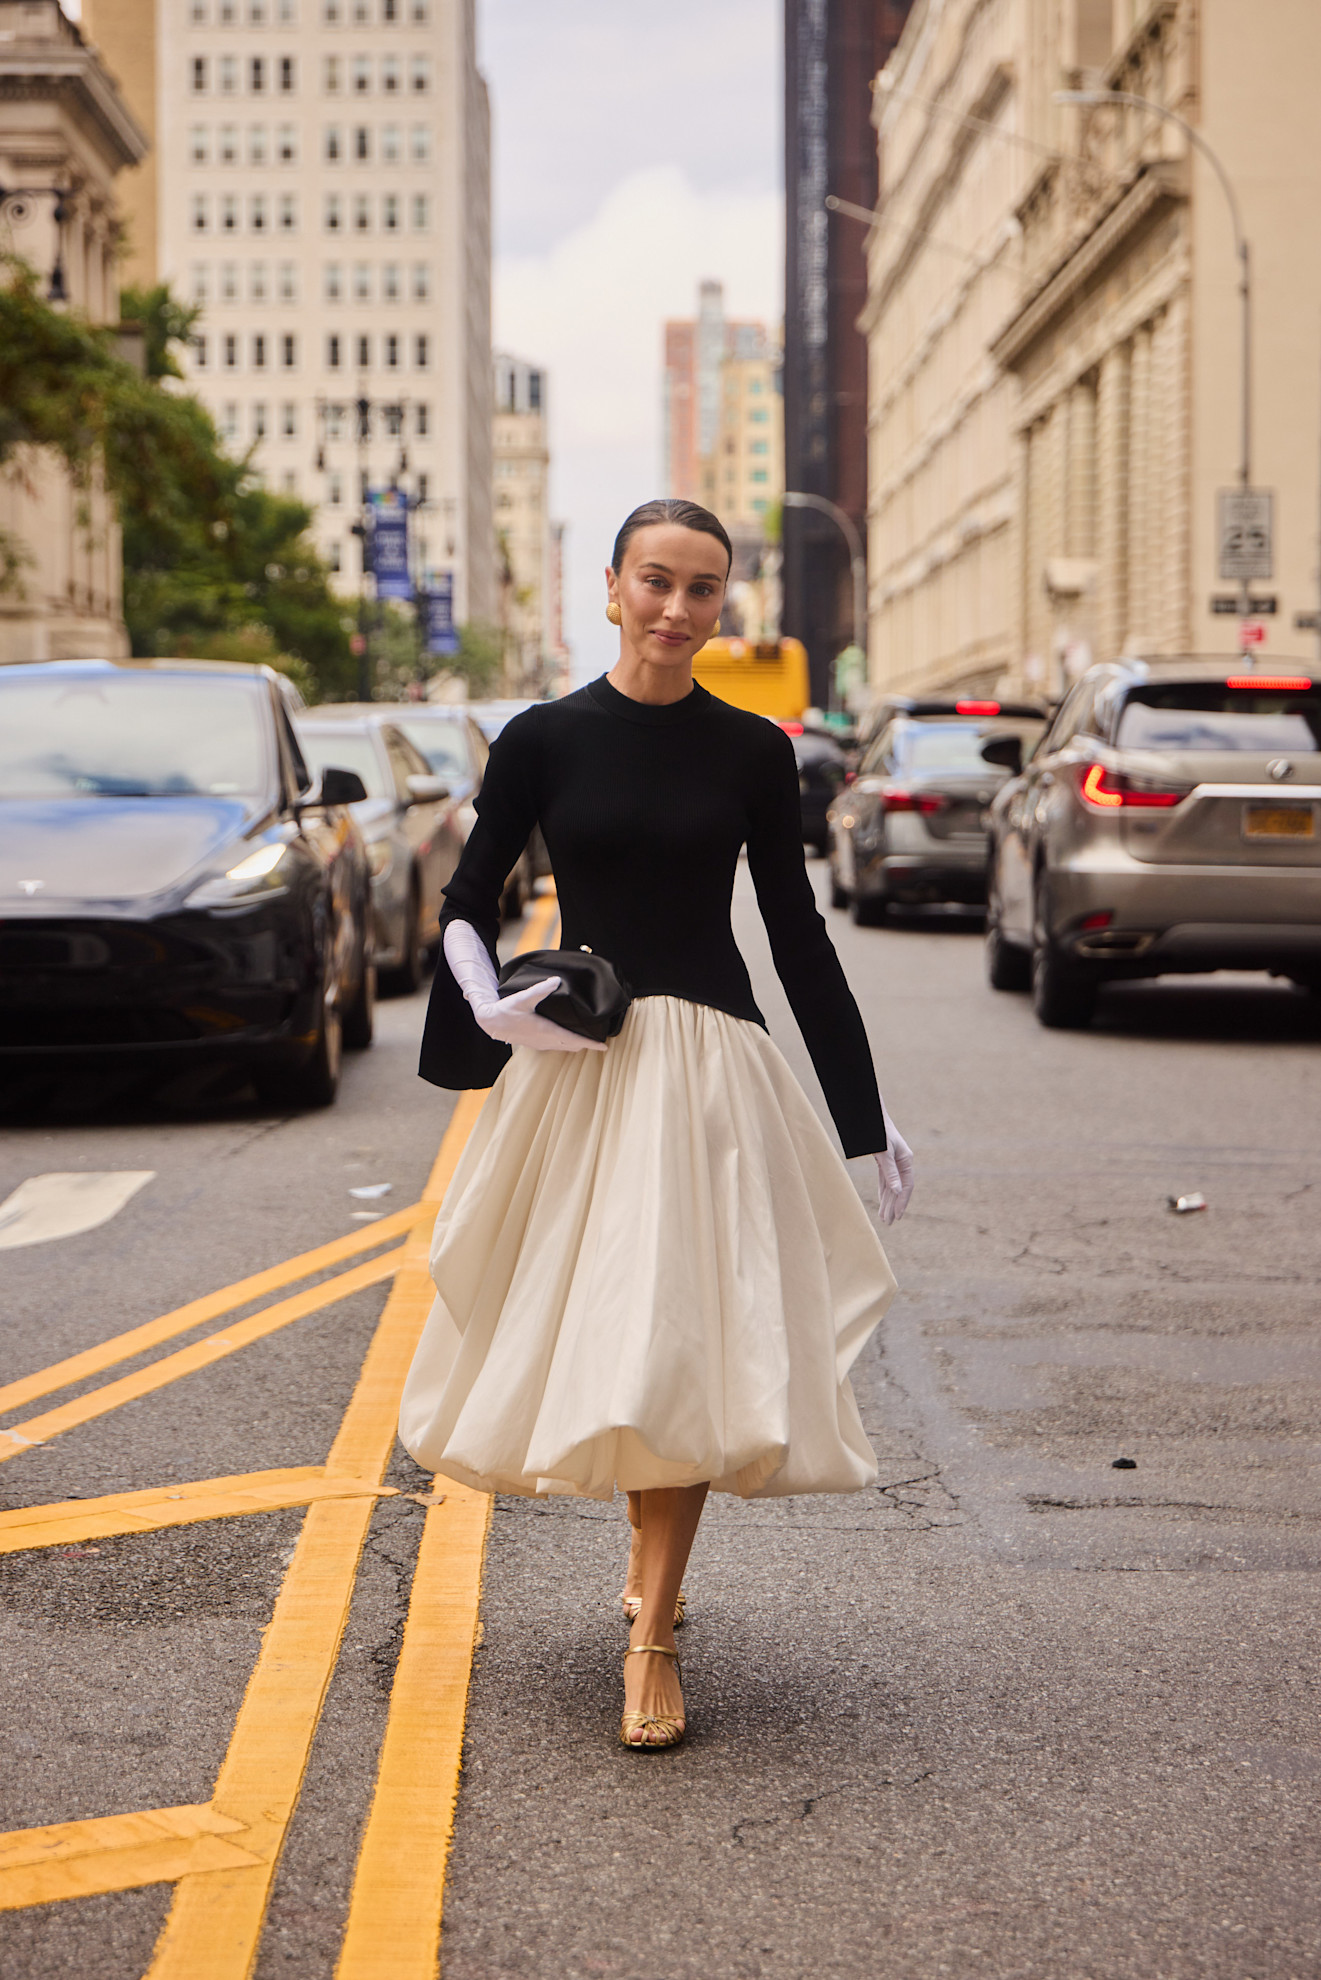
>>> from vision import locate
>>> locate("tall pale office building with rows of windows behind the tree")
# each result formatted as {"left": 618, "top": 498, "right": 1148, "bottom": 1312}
{"left": 85, "top": 0, "right": 495, "bottom": 620}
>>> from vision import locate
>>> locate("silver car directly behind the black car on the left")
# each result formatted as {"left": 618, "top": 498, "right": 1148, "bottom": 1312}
{"left": 297, "top": 703, "right": 455, "bottom": 994}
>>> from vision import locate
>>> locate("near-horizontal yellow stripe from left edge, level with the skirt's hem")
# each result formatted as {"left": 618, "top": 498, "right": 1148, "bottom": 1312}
{"left": 0, "top": 1465, "right": 396, "bottom": 1554}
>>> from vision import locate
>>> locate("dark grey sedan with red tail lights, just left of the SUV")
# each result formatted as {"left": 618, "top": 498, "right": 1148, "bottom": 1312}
{"left": 830, "top": 697, "right": 1046, "bottom": 927}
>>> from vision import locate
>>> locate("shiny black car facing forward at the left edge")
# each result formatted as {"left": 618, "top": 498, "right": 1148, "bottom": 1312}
{"left": 0, "top": 659, "right": 374, "bottom": 1107}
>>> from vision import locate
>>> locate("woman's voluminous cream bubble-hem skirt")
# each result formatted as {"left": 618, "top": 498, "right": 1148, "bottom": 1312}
{"left": 400, "top": 996, "right": 895, "bottom": 1499}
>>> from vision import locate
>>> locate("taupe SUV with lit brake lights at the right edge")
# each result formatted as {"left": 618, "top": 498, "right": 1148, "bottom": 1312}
{"left": 986, "top": 659, "right": 1321, "bottom": 1026}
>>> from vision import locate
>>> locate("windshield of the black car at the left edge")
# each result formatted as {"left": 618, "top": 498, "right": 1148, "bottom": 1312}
{"left": 0, "top": 669, "right": 269, "bottom": 798}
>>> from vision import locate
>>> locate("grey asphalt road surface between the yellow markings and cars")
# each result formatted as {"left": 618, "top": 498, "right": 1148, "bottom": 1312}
{"left": 0, "top": 883, "right": 1321, "bottom": 1980}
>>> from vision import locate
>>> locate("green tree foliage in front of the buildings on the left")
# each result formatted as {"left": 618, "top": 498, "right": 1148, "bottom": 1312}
{"left": 0, "top": 259, "right": 355, "bottom": 699}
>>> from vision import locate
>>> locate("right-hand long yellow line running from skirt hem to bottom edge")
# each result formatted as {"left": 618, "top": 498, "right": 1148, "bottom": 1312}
{"left": 335, "top": 1481, "right": 491, "bottom": 1980}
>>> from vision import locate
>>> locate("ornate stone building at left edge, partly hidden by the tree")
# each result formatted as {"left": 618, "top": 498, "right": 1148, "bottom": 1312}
{"left": 0, "top": 0, "right": 147, "bottom": 661}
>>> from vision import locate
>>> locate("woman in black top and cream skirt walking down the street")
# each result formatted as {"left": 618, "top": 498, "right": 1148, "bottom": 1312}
{"left": 400, "top": 501, "right": 913, "bottom": 1750}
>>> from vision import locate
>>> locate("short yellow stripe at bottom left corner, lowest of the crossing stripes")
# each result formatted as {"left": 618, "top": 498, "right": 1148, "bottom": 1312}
{"left": 0, "top": 1808, "right": 254, "bottom": 1911}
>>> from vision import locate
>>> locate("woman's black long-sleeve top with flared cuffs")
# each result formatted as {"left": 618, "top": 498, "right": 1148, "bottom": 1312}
{"left": 420, "top": 677, "right": 885, "bottom": 1154}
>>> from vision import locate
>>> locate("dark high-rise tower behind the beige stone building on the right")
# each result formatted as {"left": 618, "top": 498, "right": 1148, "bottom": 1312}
{"left": 784, "top": 0, "right": 911, "bottom": 705}
